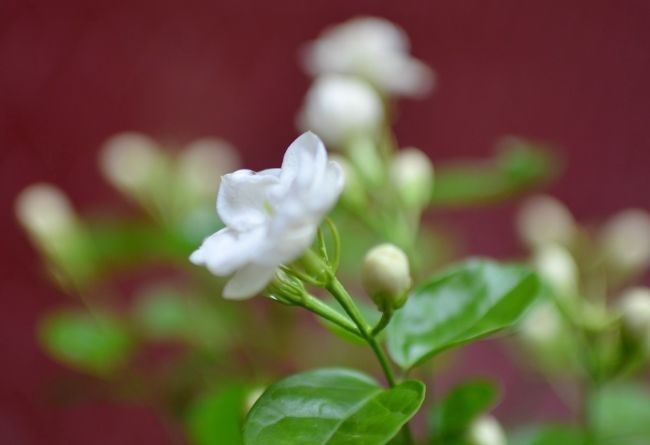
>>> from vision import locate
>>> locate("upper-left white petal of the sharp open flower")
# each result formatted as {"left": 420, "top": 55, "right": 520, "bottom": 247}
{"left": 217, "top": 169, "right": 279, "bottom": 231}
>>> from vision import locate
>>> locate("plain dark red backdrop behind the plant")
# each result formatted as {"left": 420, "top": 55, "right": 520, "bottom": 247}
{"left": 0, "top": 0, "right": 650, "bottom": 445}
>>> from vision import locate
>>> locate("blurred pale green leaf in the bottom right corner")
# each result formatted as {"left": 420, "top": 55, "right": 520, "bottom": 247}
{"left": 591, "top": 383, "right": 650, "bottom": 445}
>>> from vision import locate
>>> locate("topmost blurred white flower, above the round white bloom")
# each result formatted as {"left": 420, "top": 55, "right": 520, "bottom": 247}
{"left": 303, "top": 17, "right": 434, "bottom": 96}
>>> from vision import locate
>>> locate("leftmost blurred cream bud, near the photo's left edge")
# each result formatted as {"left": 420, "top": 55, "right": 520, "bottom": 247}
{"left": 15, "top": 184, "right": 76, "bottom": 241}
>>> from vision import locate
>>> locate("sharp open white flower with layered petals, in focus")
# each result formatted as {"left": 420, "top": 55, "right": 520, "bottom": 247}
{"left": 190, "top": 132, "right": 344, "bottom": 299}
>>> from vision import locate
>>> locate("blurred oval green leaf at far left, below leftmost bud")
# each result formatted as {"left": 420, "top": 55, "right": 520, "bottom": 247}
{"left": 39, "top": 310, "right": 133, "bottom": 376}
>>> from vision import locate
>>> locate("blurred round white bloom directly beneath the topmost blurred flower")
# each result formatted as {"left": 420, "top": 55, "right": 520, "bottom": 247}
{"left": 298, "top": 75, "right": 384, "bottom": 146}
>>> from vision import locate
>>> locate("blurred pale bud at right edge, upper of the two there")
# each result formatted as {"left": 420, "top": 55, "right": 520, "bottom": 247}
{"left": 601, "top": 209, "right": 650, "bottom": 271}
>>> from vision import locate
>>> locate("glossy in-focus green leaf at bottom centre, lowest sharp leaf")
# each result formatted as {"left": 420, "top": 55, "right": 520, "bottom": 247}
{"left": 244, "top": 369, "right": 425, "bottom": 445}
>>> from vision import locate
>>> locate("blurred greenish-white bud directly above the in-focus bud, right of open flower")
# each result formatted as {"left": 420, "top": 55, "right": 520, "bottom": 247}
{"left": 390, "top": 147, "right": 433, "bottom": 208}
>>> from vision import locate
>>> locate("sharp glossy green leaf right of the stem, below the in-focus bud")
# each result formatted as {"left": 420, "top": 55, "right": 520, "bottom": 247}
{"left": 387, "top": 259, "right": 539, "bottom": 369}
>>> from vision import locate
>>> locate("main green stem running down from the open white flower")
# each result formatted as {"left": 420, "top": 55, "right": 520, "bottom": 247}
{"left": 326, "top": 276, "right": 413, "bottom": 445}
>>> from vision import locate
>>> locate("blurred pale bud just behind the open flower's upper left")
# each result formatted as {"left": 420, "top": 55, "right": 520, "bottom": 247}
{"left": 177, "top": 138, "right": 241, "bottom": 199}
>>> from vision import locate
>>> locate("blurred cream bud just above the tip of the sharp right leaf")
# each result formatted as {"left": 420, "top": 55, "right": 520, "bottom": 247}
{"left": 535, "top": 244, "right": 578, "bottom": 299}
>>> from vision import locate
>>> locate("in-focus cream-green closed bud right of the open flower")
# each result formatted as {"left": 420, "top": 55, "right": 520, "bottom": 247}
{"left": 362, "top": 244, "right": 411, "bottom": 312}
